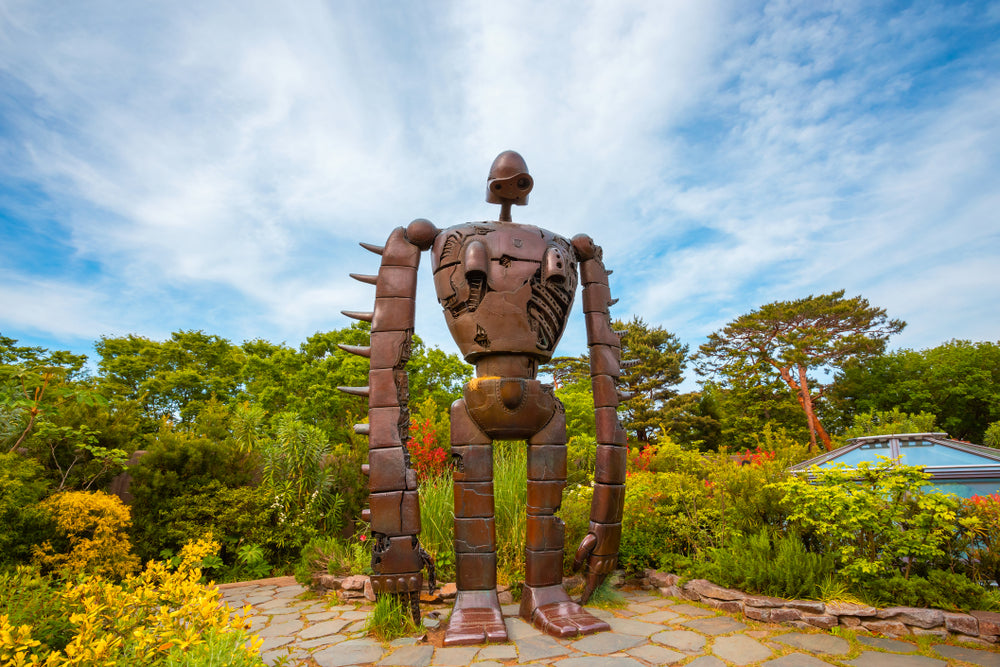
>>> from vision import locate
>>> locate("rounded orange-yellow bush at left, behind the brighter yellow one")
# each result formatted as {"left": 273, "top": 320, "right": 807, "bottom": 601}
{"left": 32, "top": 491, "right": 139, "bottom": 579}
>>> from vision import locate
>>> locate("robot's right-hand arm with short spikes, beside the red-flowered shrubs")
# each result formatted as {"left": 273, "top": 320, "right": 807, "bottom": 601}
{"left": 573, "top": 234, "right": 628, "bottom": 604}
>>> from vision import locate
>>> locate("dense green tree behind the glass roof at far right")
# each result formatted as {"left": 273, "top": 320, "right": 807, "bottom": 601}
{"left": 830, "top": 340, "right": 1000, "bottom": 443}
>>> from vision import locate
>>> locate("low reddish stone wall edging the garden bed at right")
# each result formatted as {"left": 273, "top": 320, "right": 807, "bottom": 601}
{"left": 643, "top": 570, "right": 1000, "bottom": 644}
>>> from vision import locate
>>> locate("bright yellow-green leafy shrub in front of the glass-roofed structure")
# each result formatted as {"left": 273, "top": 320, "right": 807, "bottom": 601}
{"left": 775, "top": 458, "right": 959, "bottom": 585}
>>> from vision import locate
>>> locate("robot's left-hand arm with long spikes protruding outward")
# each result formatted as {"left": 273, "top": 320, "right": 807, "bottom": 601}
{"left": 339, "top": 220, "right": 438, "bottom": 613}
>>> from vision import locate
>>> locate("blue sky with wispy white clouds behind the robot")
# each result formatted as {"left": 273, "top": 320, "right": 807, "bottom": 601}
{"left": 0, "top": 0, "right": 1000, "bottom": 384}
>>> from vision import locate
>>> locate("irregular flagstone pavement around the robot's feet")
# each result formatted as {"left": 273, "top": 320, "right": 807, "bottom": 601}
{"left": 219, "top": 577, "right": 1000, "bottom": 667}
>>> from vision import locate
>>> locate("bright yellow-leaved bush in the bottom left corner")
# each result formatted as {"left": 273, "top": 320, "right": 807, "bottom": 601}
{"left": 0, "top": 536, "right": 262, "bottom": 667}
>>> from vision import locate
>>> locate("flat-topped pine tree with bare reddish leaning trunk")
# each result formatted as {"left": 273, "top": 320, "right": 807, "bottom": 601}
{"left": 701, "top": 290, "right": 906, "bottom": 450}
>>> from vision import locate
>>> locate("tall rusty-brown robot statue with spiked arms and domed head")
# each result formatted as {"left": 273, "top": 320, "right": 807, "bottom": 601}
{"left": 340, "top": 151, "right": 626, "bottom": 645}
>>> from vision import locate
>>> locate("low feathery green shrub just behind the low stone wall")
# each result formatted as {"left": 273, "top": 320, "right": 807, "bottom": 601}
{"left": 705, "top": 530, "right": 834, "bottom": 599}
